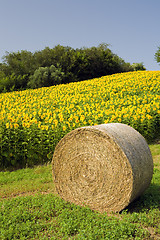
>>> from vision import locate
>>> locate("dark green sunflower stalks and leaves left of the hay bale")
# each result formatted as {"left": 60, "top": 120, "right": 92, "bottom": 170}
{"left": 0, "top": 123, "right": 58, "bottom": 170}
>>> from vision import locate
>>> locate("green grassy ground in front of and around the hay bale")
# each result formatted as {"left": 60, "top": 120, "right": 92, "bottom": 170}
{"left": 0, "top": 144, "right": 160, "bottom": 240}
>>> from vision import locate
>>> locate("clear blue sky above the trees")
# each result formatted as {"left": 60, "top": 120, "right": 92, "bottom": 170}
{"left": 0, "top": 0, "right": 160, "bottom": 70}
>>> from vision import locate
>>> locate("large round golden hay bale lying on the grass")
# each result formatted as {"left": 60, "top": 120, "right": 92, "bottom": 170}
{"left": 52, "top": 123, "right": 153, "bottom": 212}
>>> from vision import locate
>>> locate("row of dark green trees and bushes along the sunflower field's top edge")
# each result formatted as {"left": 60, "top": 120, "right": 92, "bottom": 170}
{"left": 0, "top": 44, "right": 145, "bottom": 92}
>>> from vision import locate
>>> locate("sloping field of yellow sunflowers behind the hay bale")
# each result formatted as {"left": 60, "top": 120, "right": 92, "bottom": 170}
{"left": 0, "top": 71, "right": 160, "bottom": 170}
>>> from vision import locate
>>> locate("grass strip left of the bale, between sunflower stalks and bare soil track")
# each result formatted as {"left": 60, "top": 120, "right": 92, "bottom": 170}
{"left": 0, "top": 164, "right": 54, "bottom": 198}
